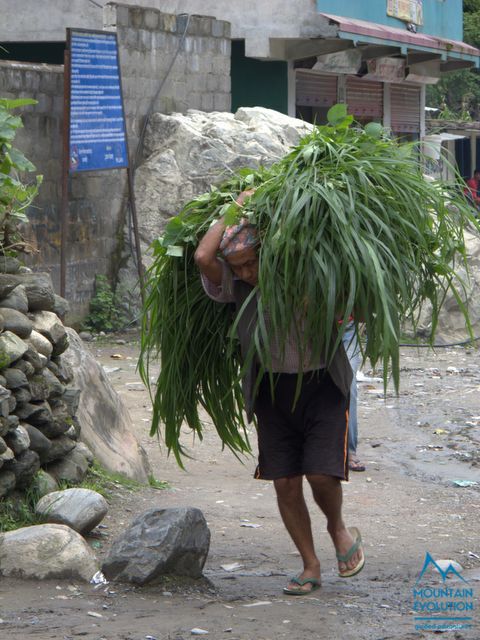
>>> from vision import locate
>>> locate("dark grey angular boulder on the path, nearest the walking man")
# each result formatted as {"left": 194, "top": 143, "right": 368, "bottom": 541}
{"left": 103, "top": 507, "right": 210, "bottom": 584}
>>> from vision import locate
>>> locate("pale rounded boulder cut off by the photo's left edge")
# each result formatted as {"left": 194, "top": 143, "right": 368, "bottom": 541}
{"left": 0, "top": 524, "right": 97, "bottom": 581}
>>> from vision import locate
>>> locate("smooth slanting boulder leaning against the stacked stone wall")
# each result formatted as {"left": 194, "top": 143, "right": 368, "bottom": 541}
{"left": 62, "top": 328, "right": 149, "bottom": 482}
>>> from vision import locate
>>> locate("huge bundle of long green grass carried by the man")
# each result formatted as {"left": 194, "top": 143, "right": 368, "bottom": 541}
{"left": 140, "top": 105, "right": 480, "bottom": 465}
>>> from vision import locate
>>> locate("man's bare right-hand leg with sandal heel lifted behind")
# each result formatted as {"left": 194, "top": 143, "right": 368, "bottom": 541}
{"left": 307, "top": 474, "right": 362, "bottom": 573}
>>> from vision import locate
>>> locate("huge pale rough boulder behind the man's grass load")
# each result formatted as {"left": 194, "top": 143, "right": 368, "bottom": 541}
{"left": 117, "top": 107, "right": 312, "bottom": 308}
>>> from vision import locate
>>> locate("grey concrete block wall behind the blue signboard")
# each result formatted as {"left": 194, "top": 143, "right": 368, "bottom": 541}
{"left": 0, "top": 5, "right": 230, "bottom": 322}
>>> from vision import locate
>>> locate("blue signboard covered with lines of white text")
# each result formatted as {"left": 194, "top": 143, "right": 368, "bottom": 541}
{"left": 69, "top": 29, "right": 128, "bottom": 173}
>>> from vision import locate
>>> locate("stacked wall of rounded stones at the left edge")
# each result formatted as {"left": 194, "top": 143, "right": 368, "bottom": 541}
{"left": 0, "top": 257, "right": 93, "bottom": 498}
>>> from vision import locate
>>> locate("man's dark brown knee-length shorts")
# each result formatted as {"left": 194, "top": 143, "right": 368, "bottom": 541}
{"left": 254, "top": 369, "right": 349, "bottom": 480}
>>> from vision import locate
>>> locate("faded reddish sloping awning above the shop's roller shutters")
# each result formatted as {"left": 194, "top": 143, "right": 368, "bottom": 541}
{"left": 320, "top": 13, "right": 480, "bottom": 67}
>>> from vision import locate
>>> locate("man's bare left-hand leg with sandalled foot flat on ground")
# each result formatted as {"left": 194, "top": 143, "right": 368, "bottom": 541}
{"left": 274, "top": 476, "right": 320, "bottom": 593}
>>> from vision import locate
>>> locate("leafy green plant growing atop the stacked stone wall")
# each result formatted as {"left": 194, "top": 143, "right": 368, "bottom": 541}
{"left": 0, "top": 98, "right": 42, "bottom": 255}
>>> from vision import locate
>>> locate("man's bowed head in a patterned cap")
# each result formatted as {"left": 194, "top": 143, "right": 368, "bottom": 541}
{"left": 220, "top": 219, "right": 259, "bottom": 287}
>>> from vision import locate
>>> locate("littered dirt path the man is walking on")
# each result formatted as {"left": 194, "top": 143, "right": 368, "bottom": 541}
{"left": 0, "top": 341, "right": 480, "bottom": 640}
